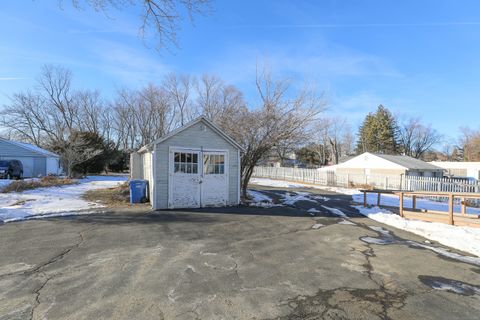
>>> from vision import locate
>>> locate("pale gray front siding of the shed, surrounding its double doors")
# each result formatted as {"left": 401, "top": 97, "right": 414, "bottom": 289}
{"left": 154, "top": 122, "right": 239, "bottom": 209}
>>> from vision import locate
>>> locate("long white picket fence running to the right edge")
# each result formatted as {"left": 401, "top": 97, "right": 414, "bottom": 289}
{"left": 253, "top": 167, "right": 480, "bottom": 193}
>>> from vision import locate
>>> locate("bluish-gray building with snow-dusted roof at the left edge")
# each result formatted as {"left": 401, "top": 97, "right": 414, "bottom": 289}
{"left": 0, "top": 138, "right": 61, "bottom": 178}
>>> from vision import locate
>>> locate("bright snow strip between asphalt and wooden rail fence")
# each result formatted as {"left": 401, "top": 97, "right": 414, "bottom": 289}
{"left": 354, "top": 206, "right": 480, "bottom": 257}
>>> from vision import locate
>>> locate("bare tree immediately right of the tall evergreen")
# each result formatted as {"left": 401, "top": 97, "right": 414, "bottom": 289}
{"left": 399, "top": 118, "right": 442, "bottom": 159}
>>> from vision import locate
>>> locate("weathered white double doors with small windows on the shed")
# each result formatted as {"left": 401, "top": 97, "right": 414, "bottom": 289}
{"left": 168, "top": 149, "right": 228, "bottom": 208}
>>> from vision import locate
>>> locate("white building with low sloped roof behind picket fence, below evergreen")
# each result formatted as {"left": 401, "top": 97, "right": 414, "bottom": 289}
{"left": 330, "top": 152, "right": 443, "bottom": 177}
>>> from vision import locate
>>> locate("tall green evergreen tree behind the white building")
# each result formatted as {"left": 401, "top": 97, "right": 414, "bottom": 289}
{"left": 356, "top": 105, "right": 399, "bottom": 154}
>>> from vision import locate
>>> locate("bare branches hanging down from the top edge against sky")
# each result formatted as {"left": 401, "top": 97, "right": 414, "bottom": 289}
{"left": 66, "top": 0, "right": 211, "bottom": 49}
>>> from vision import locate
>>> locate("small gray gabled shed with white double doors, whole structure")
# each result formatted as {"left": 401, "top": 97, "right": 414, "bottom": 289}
{"left": 130, "top": 117, "right": 243, "bottom": 210}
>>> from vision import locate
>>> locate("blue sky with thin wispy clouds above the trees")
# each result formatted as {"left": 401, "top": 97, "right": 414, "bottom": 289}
{"left": 0, "top": 0, "right": 480, "bottom": 138}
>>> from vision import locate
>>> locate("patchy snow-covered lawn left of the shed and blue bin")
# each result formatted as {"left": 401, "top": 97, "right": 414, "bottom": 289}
{"left": 0, "top": 176, "right": 127, "bottom": 222}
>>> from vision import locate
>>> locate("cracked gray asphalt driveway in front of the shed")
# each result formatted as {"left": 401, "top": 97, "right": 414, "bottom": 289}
{"left": 0, "top": 187, "right": 480, "bottom": 320}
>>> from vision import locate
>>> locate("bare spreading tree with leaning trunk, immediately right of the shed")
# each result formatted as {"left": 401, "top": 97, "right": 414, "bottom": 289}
{"left": 218, "top": 70, "right": 325, "bottom": 197}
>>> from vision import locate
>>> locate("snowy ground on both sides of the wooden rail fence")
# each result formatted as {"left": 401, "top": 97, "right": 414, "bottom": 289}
{"left": 251, "top": 178, "right": 480, "bottom": 257}
